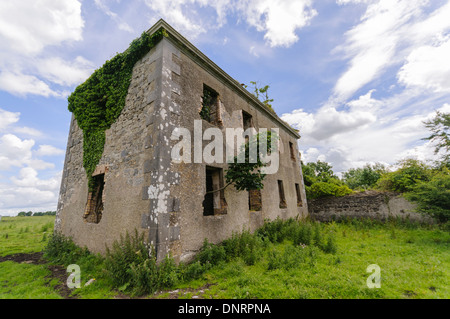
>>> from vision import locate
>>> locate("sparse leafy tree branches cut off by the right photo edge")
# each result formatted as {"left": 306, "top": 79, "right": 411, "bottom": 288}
{"left": 424, "top": 111, "right": 450, "bottom": 162}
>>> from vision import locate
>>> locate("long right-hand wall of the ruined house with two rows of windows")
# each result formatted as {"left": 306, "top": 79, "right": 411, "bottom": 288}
{"left": 172, "top": 37, "right": 308, "bottom": 260}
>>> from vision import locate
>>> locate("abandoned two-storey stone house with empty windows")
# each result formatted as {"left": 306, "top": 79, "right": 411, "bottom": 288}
{"left": 55, "top": 20, "right": 308, "bottom": 261}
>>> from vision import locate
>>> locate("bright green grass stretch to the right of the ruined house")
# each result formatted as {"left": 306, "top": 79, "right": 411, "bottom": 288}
{"left": 160, "top": 223, "right": 450, "bottom": 299}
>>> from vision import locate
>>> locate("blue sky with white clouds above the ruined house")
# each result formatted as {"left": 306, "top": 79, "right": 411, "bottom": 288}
{"left": 0, "top": 0, "right": 450, "bottom": 215}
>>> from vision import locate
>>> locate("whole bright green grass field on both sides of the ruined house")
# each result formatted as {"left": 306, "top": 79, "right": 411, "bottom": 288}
{"left": 0, "top": 216, "right": 450, "bottom": 299}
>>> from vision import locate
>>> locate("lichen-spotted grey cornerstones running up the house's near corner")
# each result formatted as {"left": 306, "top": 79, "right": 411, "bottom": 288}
{"left": 142, "top": 39, "right": 180, "bottom": 260}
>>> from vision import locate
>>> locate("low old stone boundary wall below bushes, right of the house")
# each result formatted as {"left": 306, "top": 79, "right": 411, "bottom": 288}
{"left": 308, "top": 191, "right": 432, "bottom": 222}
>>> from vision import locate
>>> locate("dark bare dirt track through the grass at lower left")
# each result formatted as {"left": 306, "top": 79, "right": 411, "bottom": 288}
{"left": 0, "top": 252, "right": 76, "bottom": 299}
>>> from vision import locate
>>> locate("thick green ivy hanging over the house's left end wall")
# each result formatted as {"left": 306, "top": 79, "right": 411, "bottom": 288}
{"left": 68, "top": 28, "right": 168, "bottom": 190}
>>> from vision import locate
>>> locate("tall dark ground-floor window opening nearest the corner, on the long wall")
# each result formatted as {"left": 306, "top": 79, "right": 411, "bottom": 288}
{"left": 203, "top": 166, "right": 227, "bottom": 216}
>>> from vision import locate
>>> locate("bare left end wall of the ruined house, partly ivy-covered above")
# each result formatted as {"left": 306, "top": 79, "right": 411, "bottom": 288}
{"left": 55, "top": 41, "right": 162, "bottom": 253}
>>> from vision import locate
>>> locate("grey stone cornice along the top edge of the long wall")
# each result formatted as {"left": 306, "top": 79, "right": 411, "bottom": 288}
{"left": 147, "top": 19, "right": 300, "bottom": 139}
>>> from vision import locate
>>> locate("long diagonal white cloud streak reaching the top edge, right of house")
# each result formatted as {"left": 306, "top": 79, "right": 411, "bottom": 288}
{"left": 334, "top": 0, "right": 426, "bottom": 100}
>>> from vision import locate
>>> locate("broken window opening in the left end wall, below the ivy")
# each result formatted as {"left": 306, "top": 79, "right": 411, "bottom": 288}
{"left": 84, "top": 173, "right": 105, "bottom": 224}
